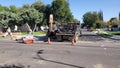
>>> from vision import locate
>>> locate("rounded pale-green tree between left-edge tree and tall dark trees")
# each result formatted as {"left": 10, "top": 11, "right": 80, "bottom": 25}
{"left": 20, "top": 8, "right": 43, "bottom": 31}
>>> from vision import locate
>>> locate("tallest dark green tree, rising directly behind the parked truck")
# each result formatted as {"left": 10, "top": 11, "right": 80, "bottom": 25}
{"left": 52, "top": 0, "right": 74, "bottom": 24}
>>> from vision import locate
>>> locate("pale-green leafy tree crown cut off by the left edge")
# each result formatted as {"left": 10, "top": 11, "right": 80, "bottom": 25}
{"left": 0, "top": 11, "right": 19, "bottom": 27}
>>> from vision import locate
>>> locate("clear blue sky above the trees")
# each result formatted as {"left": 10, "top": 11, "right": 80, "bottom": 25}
{"left": 0, "top": 0, "right": 120, "bottom": 22}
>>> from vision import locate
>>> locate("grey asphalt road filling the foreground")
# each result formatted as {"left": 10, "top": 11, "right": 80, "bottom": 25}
{"left": 0, "top": 31, "right": 120, "bottom": 68}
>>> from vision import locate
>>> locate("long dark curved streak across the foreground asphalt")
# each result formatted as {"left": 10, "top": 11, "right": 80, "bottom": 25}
{"left": 33, "top": 50, "right": 84, "bottom": 68}
